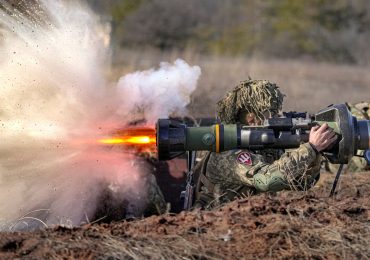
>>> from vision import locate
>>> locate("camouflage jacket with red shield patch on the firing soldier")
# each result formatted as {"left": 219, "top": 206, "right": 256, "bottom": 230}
{"left": 194, "top": 143, "right": 321, "bottom": 208}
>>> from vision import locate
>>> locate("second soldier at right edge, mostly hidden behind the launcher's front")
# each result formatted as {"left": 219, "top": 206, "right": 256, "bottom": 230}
{"left": 325, "top": 102, "right": 370, "bottom": 173}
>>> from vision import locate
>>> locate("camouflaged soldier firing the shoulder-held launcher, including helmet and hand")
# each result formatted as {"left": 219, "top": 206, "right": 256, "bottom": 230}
{"left": 194, "top": 80, "right": 336, "bottom": 209}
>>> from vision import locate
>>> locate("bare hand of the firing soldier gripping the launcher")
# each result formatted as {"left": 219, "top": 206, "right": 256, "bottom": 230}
{"left": 309, "top": 123, "right": 337, "bottom": 152}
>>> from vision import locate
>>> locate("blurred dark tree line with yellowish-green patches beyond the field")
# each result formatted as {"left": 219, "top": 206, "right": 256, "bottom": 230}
{"left": 88, "top": 0, "right": 370, "bottom": 64}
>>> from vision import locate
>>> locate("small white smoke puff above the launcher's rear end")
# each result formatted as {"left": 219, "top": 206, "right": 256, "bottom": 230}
{"left": 118, "top": 60, "right": 201, "bottom": 124}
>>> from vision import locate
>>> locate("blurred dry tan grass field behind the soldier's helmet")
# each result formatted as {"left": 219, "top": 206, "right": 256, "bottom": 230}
{"left": 111, "top": 50, "right": 370, "bottom": 116}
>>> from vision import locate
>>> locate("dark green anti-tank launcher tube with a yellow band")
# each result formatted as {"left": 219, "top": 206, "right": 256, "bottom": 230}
{"left": 156, "top": 104, "right": 370, "bottom": 163}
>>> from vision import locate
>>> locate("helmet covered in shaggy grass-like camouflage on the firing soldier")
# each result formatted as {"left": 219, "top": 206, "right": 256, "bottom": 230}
{"left": 217, "top": 80, "right": 285, "bottom": 124}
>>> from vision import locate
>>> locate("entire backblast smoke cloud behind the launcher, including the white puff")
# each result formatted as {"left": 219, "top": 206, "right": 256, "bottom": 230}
{"left": 0, "top": 0, "right": 200, "bottom": 230}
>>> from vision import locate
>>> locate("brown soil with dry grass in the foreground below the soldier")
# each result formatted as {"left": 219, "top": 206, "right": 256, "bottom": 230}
{"left": 0, "top": 173, "right": 370, "bottom": 259}
